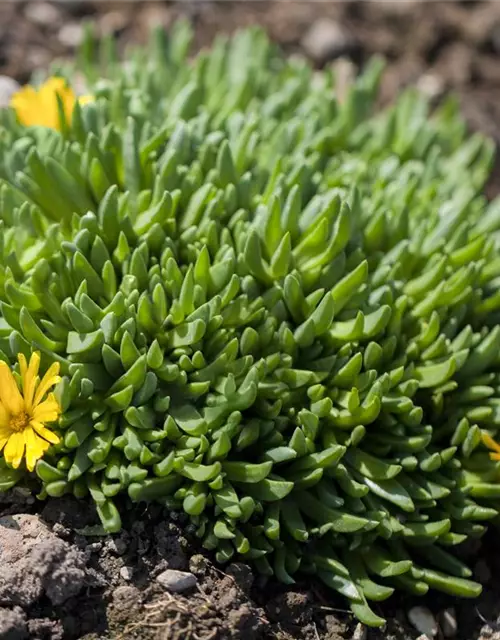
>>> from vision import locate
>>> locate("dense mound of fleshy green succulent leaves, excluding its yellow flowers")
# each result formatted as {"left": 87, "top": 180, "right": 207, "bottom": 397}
{"left": 0, "top": 24, "right": 500, "bottom": 625}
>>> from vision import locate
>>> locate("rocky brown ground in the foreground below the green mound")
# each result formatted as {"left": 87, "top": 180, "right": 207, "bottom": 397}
{"left": 0, "top": 490, "right": 500, "bottom": 640}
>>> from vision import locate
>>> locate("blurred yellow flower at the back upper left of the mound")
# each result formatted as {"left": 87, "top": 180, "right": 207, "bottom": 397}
{"left": 10, "top": 77, "right": 93, "bottom": 130}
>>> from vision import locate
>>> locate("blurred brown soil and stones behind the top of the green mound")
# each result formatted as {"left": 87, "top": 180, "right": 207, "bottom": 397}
{"left": 0, "top": 0, "right": 500, "bottom": 189}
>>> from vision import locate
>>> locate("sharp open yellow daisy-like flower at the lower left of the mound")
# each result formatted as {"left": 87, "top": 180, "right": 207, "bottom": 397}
{"left": 0, "top": 353, "right": 61, "bottom": 471}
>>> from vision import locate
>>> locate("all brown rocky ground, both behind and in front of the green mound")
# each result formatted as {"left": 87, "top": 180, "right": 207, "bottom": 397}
{"left": 0, "top": 0, "right": 500, "bottom": 640}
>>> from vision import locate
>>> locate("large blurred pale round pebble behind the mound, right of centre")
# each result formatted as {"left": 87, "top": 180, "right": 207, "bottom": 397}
{"left": 301, "top": 18, "right": 356, "bottom": 64}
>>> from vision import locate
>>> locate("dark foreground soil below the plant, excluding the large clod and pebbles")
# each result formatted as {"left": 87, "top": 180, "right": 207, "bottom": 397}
{"left": 0, "top": 490, "right": 500, "bottom": 640}
